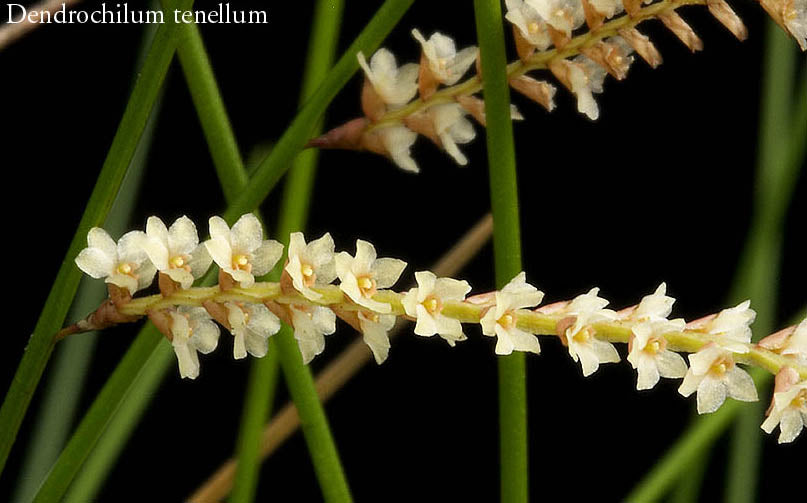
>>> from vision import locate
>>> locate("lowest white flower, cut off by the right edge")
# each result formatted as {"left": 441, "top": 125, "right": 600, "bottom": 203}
{"left": 761, "top": 367, "right": 807, "bottom": 444}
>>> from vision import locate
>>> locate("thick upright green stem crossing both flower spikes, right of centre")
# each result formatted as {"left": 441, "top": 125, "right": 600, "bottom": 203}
{"left": 474, "top": 0, "right": 529, "bottom": 502}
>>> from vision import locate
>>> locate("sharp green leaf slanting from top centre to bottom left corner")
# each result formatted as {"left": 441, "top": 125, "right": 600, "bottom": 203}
{"left": 36, "top": 0, "right": 414, "bottom": 499}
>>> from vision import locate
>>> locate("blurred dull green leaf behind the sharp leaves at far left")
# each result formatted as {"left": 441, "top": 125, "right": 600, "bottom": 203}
{"left": 12, "top": 24, "right": 162, "bottom": 501}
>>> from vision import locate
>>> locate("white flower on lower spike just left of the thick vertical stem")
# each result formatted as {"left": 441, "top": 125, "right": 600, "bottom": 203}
{"left": 401, "top": 271, "right": 471, "bottom": 346}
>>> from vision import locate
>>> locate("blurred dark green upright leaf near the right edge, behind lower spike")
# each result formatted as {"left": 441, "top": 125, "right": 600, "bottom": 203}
{"left": 724, "top": 21, "right": 800, "bottom": 503}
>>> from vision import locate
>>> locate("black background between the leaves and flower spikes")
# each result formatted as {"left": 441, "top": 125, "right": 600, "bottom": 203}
{"left": 0, "top": 0, "right": 807, "bottom": 501}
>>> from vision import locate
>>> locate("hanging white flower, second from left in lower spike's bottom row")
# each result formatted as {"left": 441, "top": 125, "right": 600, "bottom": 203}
{"left": 224, "top": 302, "right": 280, "bottom": 360}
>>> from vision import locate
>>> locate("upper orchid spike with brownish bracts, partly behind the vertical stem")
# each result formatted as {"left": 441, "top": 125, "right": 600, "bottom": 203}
{"left": 309, "top": 0, "right": 807, "bottom": 172}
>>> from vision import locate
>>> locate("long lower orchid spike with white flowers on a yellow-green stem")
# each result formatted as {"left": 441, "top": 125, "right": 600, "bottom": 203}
{"left": 69, "top": 214, "right": 807, "bottom": 442}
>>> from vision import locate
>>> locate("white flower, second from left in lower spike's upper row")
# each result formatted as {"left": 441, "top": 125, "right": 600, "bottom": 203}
{"left": 142, "top": 216, "right": 213, "bottom": 288}
